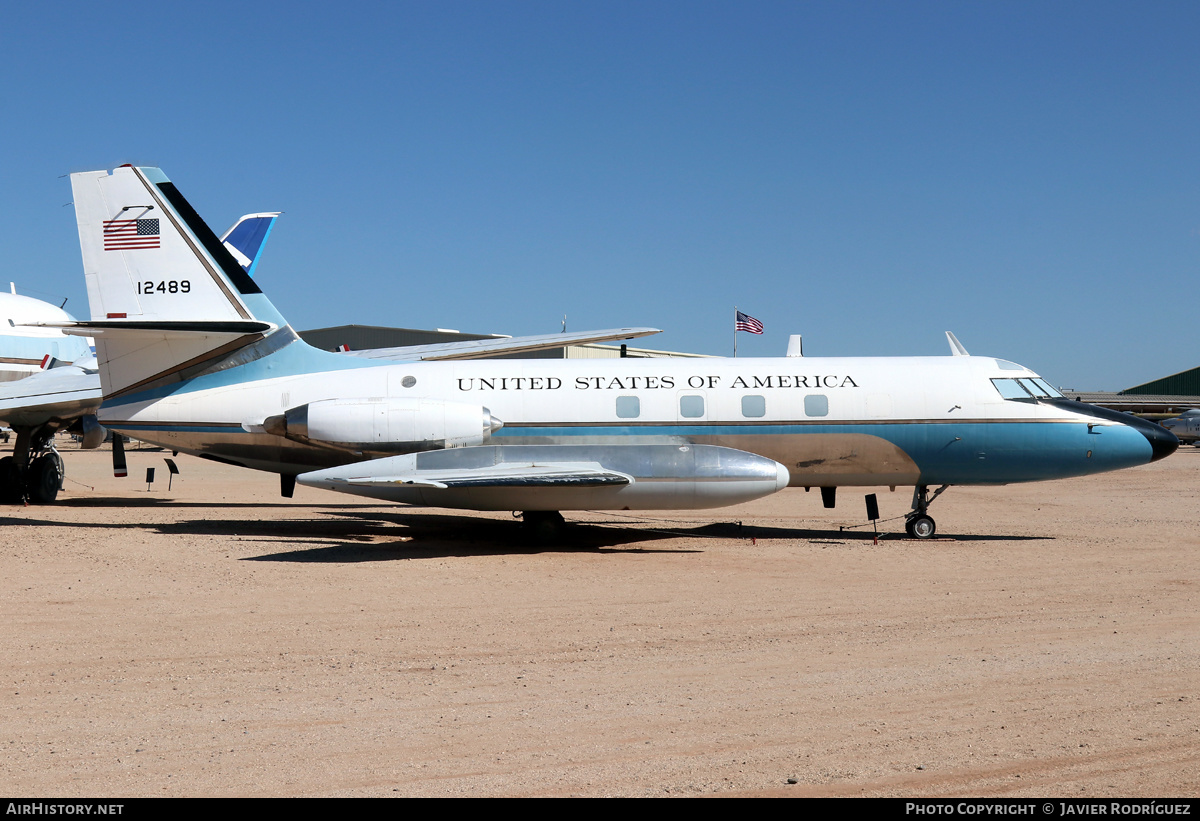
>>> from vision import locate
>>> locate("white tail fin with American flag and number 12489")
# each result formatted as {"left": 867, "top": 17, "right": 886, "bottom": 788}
{"left": 68, "top": 166, "right": 338, "bottom": 398}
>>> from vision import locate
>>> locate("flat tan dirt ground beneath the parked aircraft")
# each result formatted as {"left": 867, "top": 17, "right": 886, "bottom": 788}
{"left": 0, "top": 448, "right": 1200, "bottom": 797}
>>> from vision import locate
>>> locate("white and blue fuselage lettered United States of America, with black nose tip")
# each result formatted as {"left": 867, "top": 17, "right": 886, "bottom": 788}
{"left": 101, "top": 341, "right": 1174, "bottom": 486}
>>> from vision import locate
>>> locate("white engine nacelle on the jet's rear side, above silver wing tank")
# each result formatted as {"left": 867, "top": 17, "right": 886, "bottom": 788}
{"left": 263, "top": 398, "right": 503, "bottom": 454}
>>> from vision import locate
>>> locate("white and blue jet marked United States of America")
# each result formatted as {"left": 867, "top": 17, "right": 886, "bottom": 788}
{"left": 49, "top": 167, "right": 1178, "bottom": 538}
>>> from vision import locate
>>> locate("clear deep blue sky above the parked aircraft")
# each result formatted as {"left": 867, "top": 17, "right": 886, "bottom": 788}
{"left": 0, "top": 0, "right": 1200, "bottom": 389}
